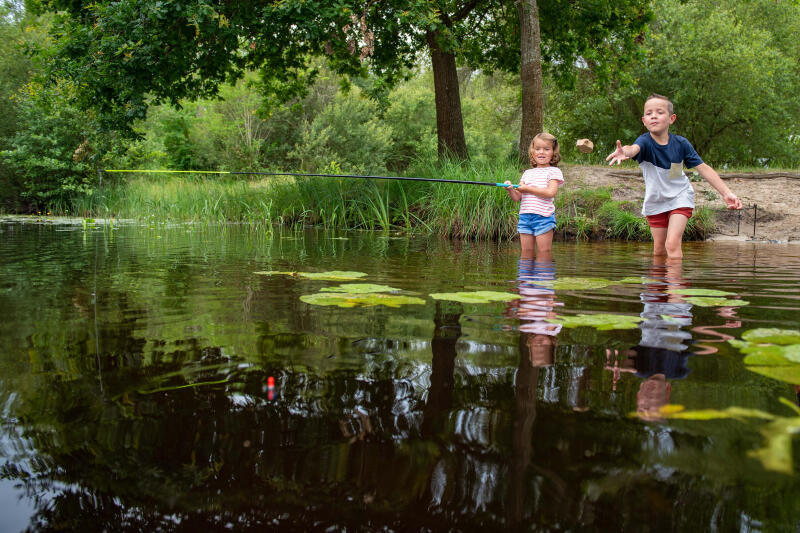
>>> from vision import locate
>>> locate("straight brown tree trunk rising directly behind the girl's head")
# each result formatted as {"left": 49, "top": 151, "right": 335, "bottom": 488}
{"left": 517, "top": 0, "right": 544, "bottom": 165}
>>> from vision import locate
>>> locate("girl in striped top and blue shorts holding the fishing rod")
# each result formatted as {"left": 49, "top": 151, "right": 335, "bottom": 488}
{"left": 505, "top": 133, "right": 564, "bottom": 261}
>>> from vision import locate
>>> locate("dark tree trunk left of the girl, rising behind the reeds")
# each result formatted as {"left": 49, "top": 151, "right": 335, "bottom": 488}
{"left": 426, "top": 30, "right": 469, "bottom": 159}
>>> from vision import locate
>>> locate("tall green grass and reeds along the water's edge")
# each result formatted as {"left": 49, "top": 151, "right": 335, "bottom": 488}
{"left": 70, "top": 160, "right": 714, "bottom": 240}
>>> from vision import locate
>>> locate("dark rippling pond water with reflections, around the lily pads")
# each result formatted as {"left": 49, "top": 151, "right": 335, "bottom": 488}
{"left": 0, "top": 220, "right": 800, "bottom": 531}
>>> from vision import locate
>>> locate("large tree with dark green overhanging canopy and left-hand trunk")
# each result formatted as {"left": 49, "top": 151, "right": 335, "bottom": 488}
{"left": 34, "top": 0, "right": 647, "bottom": 164}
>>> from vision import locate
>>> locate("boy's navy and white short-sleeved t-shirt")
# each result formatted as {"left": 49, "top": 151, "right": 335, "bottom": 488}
{"left": 634, "top": 133, "right": 703, "bottom": 216}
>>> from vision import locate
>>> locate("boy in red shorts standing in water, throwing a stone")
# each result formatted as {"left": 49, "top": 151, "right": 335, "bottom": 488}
{"left": 606, "top": 94, "right": 742, "bottom": 259}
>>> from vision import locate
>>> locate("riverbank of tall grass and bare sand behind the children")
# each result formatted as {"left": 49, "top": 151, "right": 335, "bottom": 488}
{"left": 6, "top": 164, "right": 800, "bottom": 243}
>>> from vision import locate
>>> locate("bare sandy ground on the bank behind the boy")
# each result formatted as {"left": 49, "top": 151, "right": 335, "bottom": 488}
{"left": 563, "top": 166, "right": 800, "bottom": 244}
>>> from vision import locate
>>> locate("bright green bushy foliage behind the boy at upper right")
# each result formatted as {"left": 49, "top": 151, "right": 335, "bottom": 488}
{"left": 548, "top": 0, "right": 800, "bottom": 167}
